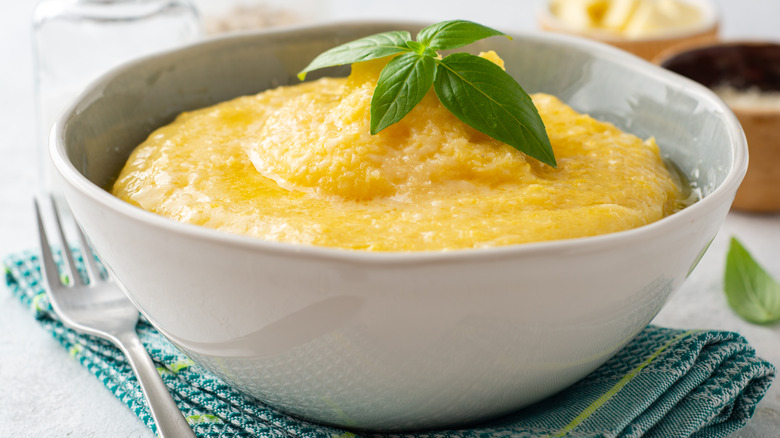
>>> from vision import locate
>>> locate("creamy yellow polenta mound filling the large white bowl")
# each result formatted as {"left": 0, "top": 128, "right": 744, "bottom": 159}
{"left": 113, "top": 55, "right": 682, "bottom": 251}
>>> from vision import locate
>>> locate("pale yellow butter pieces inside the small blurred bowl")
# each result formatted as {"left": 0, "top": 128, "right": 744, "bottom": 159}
{"left": 550, "top": 0, "right": 704, "bottom": 38}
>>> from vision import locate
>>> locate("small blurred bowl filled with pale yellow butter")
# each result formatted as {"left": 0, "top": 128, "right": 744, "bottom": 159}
{"left": 537, "top": 0, "right": 720, "bottom": 60}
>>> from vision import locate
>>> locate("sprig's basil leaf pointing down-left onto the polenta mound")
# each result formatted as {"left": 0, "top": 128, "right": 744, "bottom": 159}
{"left": 371, "top": 52, "right": 436, "bottom": 134}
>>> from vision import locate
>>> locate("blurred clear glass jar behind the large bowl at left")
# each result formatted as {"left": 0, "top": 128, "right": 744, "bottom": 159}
{"left": 32, "top": 0, "right": 203, "bottom": 192}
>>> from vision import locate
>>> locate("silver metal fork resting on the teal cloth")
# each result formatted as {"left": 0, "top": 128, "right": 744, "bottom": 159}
{"left": 35, "top": 199, "right": 195, "bottom": 437}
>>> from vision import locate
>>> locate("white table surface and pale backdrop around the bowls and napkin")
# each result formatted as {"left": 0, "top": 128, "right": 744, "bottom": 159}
{"left": 0, "top": 0, "right": 780, "bottom": 437}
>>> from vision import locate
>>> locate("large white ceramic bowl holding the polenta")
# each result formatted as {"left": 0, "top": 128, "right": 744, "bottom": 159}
{"left": 52, "top": 23, "right": 747, "bottom": 430}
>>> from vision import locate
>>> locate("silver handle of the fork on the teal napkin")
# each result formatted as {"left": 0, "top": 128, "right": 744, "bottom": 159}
{"left": 116, "top": 330, "right": 195, "bottom": 438}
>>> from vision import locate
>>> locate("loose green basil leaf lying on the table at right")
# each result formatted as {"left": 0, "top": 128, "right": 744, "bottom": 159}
{"left": 724, "top": 238, "right": 780, "bottom": 324}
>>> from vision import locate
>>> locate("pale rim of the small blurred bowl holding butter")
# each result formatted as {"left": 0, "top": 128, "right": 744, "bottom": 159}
{"left": 536, "top": 0, "right": 721, "bottom": 43}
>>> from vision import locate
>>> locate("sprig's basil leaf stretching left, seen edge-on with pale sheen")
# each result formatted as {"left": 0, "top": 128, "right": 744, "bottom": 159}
{"left": 298, "top": 31, "right": 412, "bottom": 80}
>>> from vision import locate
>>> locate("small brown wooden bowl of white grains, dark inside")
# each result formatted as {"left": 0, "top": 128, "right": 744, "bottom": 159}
{"left": 654, "top": 41, "right": 780, "bottom": 212}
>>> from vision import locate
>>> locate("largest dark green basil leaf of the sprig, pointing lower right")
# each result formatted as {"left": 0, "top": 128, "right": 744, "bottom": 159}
{"left": 434, "top": 53, "right": 557, "bottom": 167}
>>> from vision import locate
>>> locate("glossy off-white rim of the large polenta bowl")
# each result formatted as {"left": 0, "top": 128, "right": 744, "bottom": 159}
{"left": 49, "top": 20, "right": 748, "bottom": 266}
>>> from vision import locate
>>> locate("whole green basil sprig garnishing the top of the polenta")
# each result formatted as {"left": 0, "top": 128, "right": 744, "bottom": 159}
{"left": 298, "top": 20, "right": 557, "bottom": 167}
